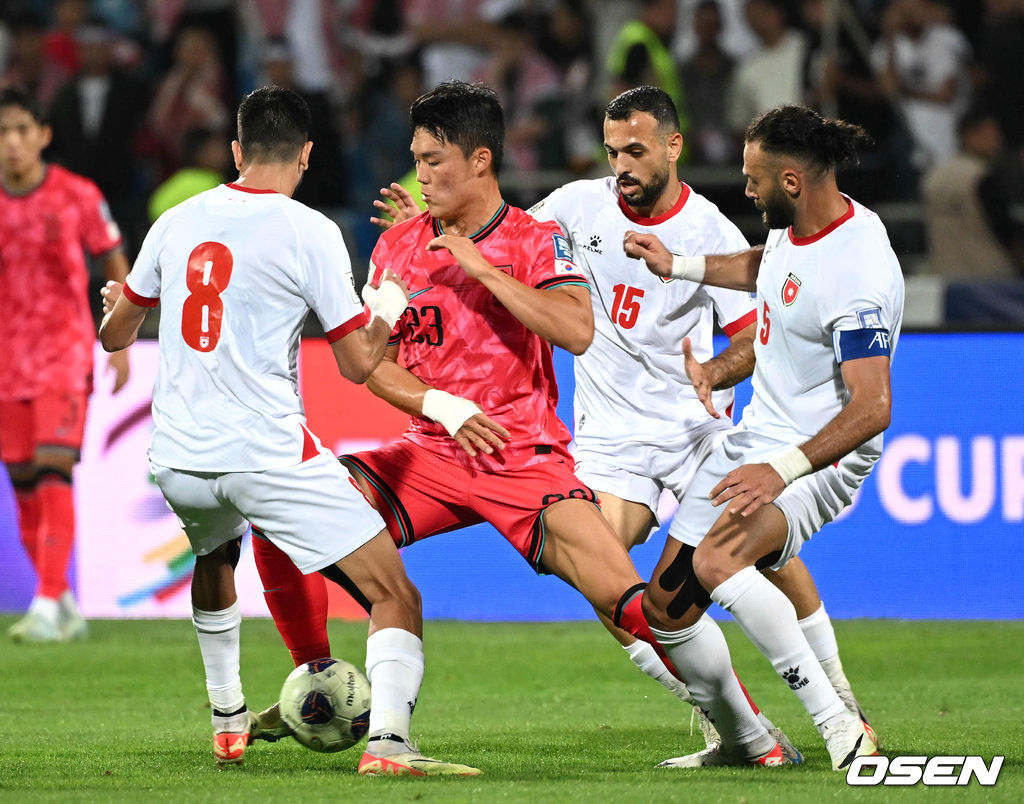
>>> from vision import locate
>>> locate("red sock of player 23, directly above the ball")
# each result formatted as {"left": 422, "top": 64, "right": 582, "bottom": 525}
{"left": 253, "top": 531, "right": 331, "bottom": 667}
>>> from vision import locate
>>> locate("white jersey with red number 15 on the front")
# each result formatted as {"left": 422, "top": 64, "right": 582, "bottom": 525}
{"left": 529, "top": 176, "right": 756, "bottom": 446}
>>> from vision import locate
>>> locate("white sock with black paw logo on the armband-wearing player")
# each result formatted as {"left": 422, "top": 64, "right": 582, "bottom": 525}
{"left": 716, "top": 566, "right": 846, "bottom": 725}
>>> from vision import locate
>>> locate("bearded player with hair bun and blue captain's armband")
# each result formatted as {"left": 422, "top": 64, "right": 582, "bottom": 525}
{"left": 625, "top": 107, "right": 903, "bottom": 770}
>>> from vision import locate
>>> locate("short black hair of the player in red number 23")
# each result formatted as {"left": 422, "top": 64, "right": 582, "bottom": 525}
{"left": 409, "top": 81, "right": 505, "bottom": 176}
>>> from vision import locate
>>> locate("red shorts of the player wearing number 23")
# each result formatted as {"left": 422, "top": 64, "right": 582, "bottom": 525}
{"left": 341, "top": 439, "right": 597, "bottom": 573}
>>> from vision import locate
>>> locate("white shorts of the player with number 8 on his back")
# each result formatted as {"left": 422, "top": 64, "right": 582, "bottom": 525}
{"left": 150, "top": 450, "right": 385, "bottom": 574}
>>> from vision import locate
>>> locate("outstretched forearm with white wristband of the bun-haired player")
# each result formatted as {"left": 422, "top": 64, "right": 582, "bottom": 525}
{"left": 623, "top": 231, "right": 764, "bottom": 291}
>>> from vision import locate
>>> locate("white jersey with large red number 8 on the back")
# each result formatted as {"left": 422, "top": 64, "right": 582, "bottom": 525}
{"left": 125, "top": 184, "right": 367, "bottom": 472}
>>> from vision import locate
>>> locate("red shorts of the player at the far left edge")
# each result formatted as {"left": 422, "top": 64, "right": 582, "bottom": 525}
{"left": 0, "top": 391, "right": 89, "bottom": 464}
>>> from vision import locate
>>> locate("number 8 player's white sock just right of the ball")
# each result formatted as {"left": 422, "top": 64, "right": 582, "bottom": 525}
{"left": 367, "top": 628, "right": 424, "bottom": 739}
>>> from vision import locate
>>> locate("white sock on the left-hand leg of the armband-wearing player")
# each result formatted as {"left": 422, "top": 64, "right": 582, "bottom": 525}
{"left": 650, "top": 613, "right": 775, "bottom": 759}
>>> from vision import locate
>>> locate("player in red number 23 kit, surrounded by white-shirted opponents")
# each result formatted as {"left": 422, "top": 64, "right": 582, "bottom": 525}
{"left": 247, "top": 82, "right": 785, "bottom": 763}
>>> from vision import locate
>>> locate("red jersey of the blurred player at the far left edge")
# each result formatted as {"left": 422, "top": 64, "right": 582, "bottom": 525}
{"left": 0, "top": 165, "right": 121, "bottom": 400}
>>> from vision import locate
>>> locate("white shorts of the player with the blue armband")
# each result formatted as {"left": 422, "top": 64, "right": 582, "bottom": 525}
{"left": 669, "top": 428, "right": 874, "bottom": 569}
